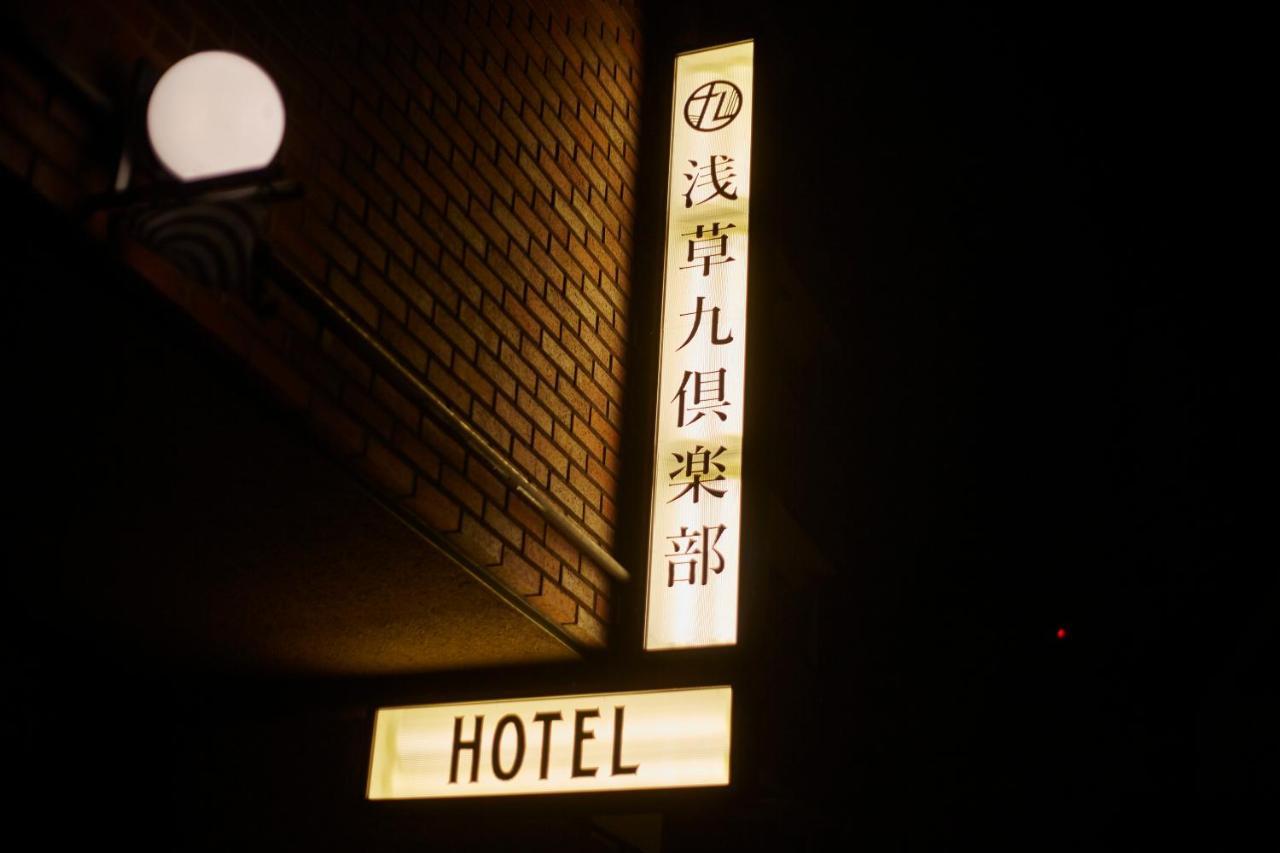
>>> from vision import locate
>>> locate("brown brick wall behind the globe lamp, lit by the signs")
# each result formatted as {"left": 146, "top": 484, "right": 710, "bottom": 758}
{"left": 0, "top": 0, "right": 640, "bottom": 644}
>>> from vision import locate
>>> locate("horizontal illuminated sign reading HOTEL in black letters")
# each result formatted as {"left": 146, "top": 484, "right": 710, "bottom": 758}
{"left": 369, "top": 686, "right": 733, "bottom": 799}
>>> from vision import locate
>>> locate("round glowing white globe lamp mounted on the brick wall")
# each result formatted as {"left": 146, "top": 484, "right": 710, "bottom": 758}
{"left": 147, "top": 50, "right": 284, "bottom": 181}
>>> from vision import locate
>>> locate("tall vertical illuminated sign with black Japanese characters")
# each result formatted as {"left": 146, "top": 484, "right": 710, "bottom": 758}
{"left": 645, "top": 41, "right": 754, "bottom": 649}
